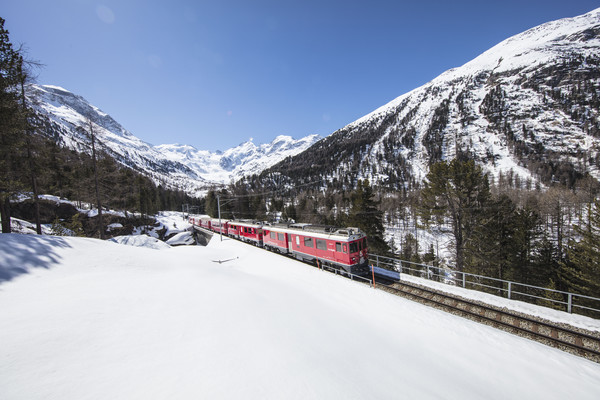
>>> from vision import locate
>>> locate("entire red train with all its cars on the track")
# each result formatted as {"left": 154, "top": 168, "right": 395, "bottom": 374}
{"left": 189, "top": 217, "right": 368, "bottom": 274}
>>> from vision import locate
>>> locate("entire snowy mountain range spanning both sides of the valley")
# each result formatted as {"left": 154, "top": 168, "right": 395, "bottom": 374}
{"left": 28, "top": 8, "right": 600, "bottom": 194}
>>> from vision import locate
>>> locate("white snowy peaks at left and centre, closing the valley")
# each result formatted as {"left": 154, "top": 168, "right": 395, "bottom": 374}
{"left": 28, "top": 85, "right": 320, "bottom": 195}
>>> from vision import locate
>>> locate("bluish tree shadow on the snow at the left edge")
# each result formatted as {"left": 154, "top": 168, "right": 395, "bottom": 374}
{"left": 0, "top": 233, "right": 71, "bottom": 284}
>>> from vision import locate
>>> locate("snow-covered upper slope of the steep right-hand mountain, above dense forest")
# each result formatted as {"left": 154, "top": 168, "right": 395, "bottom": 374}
{"left": 345, "top": 8, "right": 600, "bottom": 178}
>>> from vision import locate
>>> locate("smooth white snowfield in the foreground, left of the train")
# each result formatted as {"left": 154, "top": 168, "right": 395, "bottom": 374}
{"left": 0, "top": 234, "right": 600, "bottom": 400}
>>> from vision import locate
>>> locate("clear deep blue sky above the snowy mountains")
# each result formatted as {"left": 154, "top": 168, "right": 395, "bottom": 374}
{"left": 0, "top": 0, "right": 600, "bottom": 150}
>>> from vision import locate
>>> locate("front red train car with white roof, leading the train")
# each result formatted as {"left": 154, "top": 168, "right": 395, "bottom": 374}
{"left": 287, "top": 224, "right": 368, "bottom": 274}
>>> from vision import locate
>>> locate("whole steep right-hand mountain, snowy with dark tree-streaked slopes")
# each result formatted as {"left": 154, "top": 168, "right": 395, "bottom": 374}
{"left": 262, "top": 9, "right": 600, "bottom": 189}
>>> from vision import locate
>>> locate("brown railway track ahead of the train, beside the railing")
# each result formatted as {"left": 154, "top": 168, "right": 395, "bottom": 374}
{"left": 376, "top": 278, "right": 600, "bottom": 363}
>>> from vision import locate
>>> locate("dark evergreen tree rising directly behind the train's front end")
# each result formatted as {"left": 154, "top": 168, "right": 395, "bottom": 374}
{"left": 349, "top": 180, "right": 390, "bottom": 255}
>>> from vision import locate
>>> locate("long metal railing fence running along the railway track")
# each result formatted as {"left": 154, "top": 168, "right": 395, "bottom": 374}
{"left": 369, "top": 254, "right": 600, "bottom": 318}
